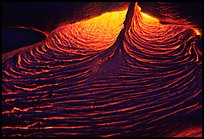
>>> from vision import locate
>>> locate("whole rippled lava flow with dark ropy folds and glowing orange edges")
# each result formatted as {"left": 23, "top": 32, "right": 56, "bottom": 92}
{"left": 2, "top": 3, "right": 202, "bottom": 137}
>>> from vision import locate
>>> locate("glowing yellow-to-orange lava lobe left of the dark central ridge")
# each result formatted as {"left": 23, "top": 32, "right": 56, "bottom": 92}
{"left": 47, "top": 9, "right": 127, "bottom": 50}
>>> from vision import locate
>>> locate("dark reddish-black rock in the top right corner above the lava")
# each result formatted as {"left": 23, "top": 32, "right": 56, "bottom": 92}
{"left": 138, "top": 2, "right": 202, "bottom": 28}
